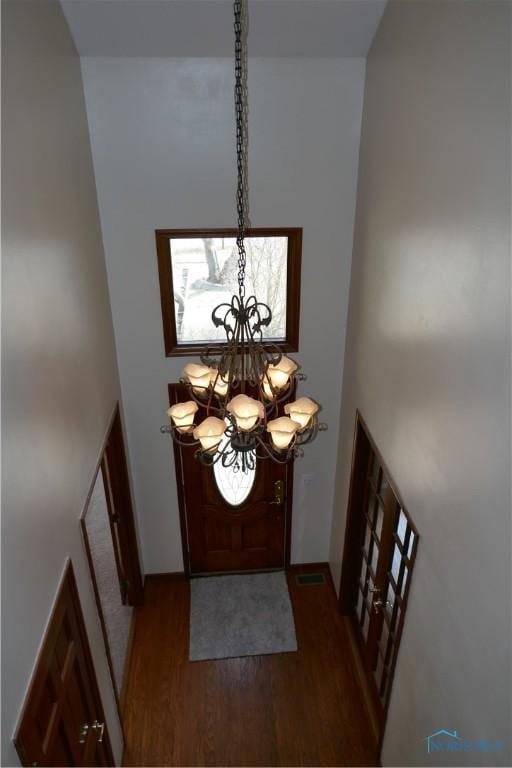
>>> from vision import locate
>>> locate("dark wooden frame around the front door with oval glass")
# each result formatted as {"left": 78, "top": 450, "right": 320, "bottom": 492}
{"left": 168, "top": 382, "right": 295, "bottom": 578}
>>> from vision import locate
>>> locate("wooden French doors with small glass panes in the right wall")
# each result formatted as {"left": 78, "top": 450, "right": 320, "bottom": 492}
{"left": 340, "top": 413, "right": 418, "bottom": 726}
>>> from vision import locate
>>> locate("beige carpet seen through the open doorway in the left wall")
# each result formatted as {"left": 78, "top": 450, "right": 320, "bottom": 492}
{"left": 85, "top": 470, "right": 133, "bottom": 693}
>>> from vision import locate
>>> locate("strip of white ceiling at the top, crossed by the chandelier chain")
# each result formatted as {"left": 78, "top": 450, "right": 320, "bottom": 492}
{"left": 61, "top": 0, "right": 386, "bottom": 57}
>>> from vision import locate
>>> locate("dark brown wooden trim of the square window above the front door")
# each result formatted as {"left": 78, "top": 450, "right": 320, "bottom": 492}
{"left": 155, "top": 227, "right": 302, "bottom": 357}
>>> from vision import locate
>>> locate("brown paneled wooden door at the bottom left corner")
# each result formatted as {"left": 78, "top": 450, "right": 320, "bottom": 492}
{"left": 14, "top": 563, "right": 114, "bottom": 766}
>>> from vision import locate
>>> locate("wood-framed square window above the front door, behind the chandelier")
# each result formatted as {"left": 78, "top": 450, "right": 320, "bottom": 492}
{"left": 156, "top": 228, "right": 302, "bottom": 356}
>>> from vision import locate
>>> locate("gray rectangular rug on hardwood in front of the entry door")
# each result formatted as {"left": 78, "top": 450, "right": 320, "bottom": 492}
{"left": 189, "top": 571, "right": 297, "bottom": 661}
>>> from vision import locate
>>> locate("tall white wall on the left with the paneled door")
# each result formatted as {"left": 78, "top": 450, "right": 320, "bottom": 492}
{"left": 2, "top": 0, "right": 121, "bottom": 765}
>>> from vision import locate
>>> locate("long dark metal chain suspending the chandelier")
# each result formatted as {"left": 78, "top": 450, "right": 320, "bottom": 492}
{"left": 233, "top": 0, "right": 248, "bottom": 299}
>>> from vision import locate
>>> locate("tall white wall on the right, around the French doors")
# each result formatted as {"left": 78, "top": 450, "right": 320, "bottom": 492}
{"left": 331, "top": 0, "right": 512, "bottom": 765}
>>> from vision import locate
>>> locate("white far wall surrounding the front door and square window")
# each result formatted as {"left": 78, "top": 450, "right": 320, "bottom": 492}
{"left": 82, "top": 58, "right": 364, "bottom": 572}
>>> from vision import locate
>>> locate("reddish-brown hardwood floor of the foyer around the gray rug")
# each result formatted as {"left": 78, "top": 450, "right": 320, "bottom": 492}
{"left": 124, "top": 567, "right": 378, "bottom": 766}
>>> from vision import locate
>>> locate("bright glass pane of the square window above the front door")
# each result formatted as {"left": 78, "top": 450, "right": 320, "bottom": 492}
{"left": 171, "top": 237, "right": 288, "bottom": 344}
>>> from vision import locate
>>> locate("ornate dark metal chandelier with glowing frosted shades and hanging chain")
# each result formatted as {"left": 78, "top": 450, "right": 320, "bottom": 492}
{"left": 160, "top": 0, "right": 327, "bottom": 472}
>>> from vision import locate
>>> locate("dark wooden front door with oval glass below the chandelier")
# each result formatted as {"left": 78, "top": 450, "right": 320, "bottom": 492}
{"left": 169, "top": 384, "right": 293, "bottom": 574}
